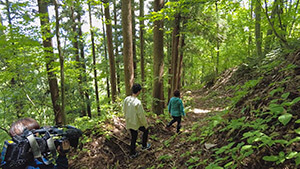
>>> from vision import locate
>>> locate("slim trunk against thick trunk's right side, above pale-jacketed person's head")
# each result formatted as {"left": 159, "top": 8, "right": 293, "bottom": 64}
{"left": 131, "top": 0, "right": 137, "bottom": 78}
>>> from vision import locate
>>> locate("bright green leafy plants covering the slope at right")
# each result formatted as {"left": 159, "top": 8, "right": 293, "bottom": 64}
{"left": 195, "top": 54, "right": 300, "bottom": 168}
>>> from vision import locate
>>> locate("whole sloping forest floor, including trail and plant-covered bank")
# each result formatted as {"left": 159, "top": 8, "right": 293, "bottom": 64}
{"left": 70, "top": 51, "right": 300, "bottom": 169}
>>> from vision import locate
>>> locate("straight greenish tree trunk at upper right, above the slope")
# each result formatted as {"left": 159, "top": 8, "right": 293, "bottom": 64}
{"left": 255, "top": 0, "right": 262, "bottom": 57}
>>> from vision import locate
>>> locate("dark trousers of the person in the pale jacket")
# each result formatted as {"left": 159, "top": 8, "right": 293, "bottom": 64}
{"left": 130, "top": 126, "right": 149, "bottom": 155}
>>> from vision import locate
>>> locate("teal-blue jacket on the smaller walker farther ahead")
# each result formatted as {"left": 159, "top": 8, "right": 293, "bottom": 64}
{"left": 168, "top": 97, "right": 185, "bottom": 117}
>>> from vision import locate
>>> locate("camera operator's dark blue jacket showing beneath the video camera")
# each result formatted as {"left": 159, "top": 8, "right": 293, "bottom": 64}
{"left": 26, "top": 155, "right": 69, "bottom": 169}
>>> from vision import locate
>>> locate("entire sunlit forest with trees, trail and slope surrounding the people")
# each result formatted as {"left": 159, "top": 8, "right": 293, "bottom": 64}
{"left": 0, "top": 0, "right": 300, "bottom": 169}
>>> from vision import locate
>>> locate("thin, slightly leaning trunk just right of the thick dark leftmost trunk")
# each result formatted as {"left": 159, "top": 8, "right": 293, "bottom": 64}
{"left": 54, "top": 0, "right": 66, "bottom": 121}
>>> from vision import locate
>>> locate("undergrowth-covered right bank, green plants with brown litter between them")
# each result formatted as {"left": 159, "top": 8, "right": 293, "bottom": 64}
{"left": 187, "top": 49, "right": 300, "bottom": 169}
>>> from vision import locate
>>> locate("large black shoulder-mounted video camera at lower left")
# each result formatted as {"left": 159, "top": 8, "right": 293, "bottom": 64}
{"left": 0, "top": 125, "right": 82, "bottom": 169}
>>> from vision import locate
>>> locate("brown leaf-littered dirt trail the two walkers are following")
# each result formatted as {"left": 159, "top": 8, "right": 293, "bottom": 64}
{"left": 70, "top": 91, "right": 222, "bottom": 169}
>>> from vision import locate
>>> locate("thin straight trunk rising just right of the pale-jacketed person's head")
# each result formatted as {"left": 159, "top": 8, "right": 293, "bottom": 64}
{"left": 140, "top": 0, "right": 145, "bottom": 104}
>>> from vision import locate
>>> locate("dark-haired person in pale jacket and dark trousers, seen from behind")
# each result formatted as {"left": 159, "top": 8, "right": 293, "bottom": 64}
{"left": 123, "top": 84, "right": 151, "bottom": 158}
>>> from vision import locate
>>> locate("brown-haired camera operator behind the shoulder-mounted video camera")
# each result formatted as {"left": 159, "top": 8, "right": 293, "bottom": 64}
{"left": 3, "top": 118, "right": 70, "bottom": 169}
